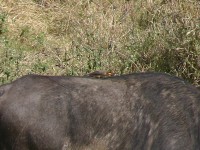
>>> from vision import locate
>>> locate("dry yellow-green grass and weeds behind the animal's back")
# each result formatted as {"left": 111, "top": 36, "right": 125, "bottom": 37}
{"left": 0, "top": 0, "right": 200, "bottom": 86}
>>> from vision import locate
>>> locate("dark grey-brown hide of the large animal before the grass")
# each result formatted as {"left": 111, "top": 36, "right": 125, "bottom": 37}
{"left": 0, "top": 73, "right": 200, "bottom": 150}
